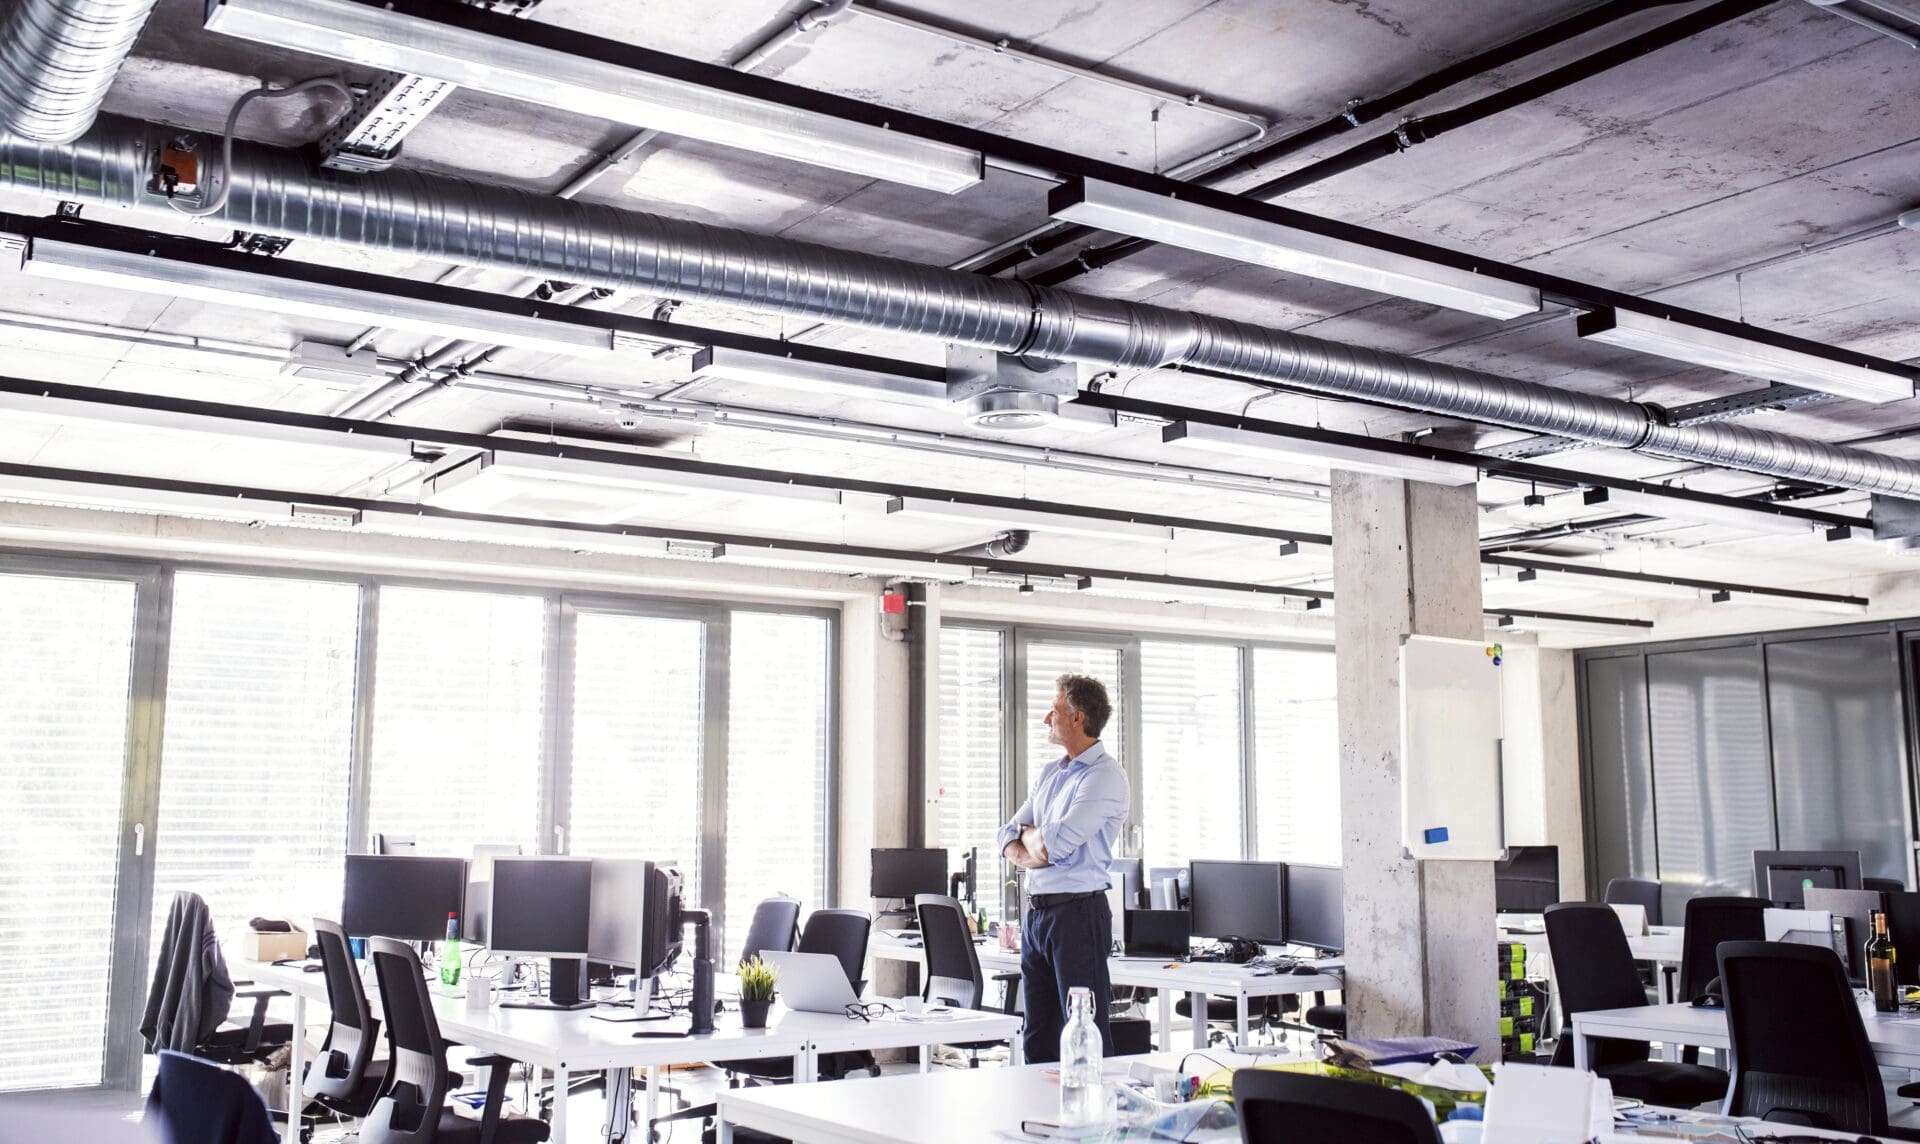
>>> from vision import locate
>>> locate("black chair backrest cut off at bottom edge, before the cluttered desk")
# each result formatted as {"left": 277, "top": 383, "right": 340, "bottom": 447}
{"left": 1233, "top": 1069, "right": 1440, "bottom": 1144}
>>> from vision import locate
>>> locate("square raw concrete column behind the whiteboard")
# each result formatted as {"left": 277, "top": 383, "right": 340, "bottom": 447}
{"left": 1332, "top": 472, "right": 1500, "bottom": 1060}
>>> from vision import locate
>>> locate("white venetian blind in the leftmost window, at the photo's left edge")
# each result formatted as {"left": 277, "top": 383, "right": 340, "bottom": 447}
{"left": 0, "top": 576, "right": 134, "bottom": 1090}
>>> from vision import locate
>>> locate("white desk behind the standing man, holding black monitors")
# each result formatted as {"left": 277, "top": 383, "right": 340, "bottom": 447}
{"left": 868, "top": 931, "right": 1346, "bottom": 1050}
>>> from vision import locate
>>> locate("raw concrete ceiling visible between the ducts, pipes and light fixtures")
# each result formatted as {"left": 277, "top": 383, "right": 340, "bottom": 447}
{"left": 0, "top": 0, "right": 1920, "bottom": 643}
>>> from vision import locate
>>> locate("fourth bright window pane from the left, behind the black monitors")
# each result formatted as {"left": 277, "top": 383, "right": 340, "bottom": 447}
{"left": 566, "top": 612, "right": 707, "bottom": 904}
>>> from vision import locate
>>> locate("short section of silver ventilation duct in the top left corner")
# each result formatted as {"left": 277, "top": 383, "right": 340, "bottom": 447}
{"left": 0, "top": 0, "right": 154, "bottom": 144}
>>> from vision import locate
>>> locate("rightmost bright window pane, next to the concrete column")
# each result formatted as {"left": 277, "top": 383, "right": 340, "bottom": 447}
{"left": 1254, "top": 647, "right": 1340, "bottom": 866}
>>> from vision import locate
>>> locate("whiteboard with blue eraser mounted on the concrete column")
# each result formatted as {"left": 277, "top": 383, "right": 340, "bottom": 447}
{"left": 1400, "top": 635, "right": 1507, "bottom": 862}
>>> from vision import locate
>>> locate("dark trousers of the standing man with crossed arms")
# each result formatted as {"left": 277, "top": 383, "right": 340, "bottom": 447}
{"left": 1020, "top": 894, "right": 1114, "bottom": 1063}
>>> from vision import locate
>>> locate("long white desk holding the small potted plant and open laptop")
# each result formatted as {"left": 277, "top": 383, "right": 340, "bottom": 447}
{"left": 240, "top": 964, "right": 1021, "bottom": 1144}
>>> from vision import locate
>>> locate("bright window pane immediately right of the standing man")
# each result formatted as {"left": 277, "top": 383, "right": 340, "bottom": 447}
{"left": 1140, "top": 643, "right": 1244, "bottom": 866}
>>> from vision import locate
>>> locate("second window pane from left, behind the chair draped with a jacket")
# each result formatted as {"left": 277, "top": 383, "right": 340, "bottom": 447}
{"left": 152, "top": 572, "right": 359, "bottom": 956}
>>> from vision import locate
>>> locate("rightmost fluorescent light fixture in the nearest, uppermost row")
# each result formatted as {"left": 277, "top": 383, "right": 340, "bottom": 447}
{"left": 1576, "top": 309, "right": 1914, "bottom": 403}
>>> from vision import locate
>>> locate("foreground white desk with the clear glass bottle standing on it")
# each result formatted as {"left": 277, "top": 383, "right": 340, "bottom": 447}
{"left": 720, "top": 1052, "right": 1277, "bottom": 1144}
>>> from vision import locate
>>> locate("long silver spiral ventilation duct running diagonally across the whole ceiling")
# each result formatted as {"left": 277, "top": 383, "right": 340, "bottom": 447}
{"left": 11, "top": 117, "right": 1920, "bottom": 497}
